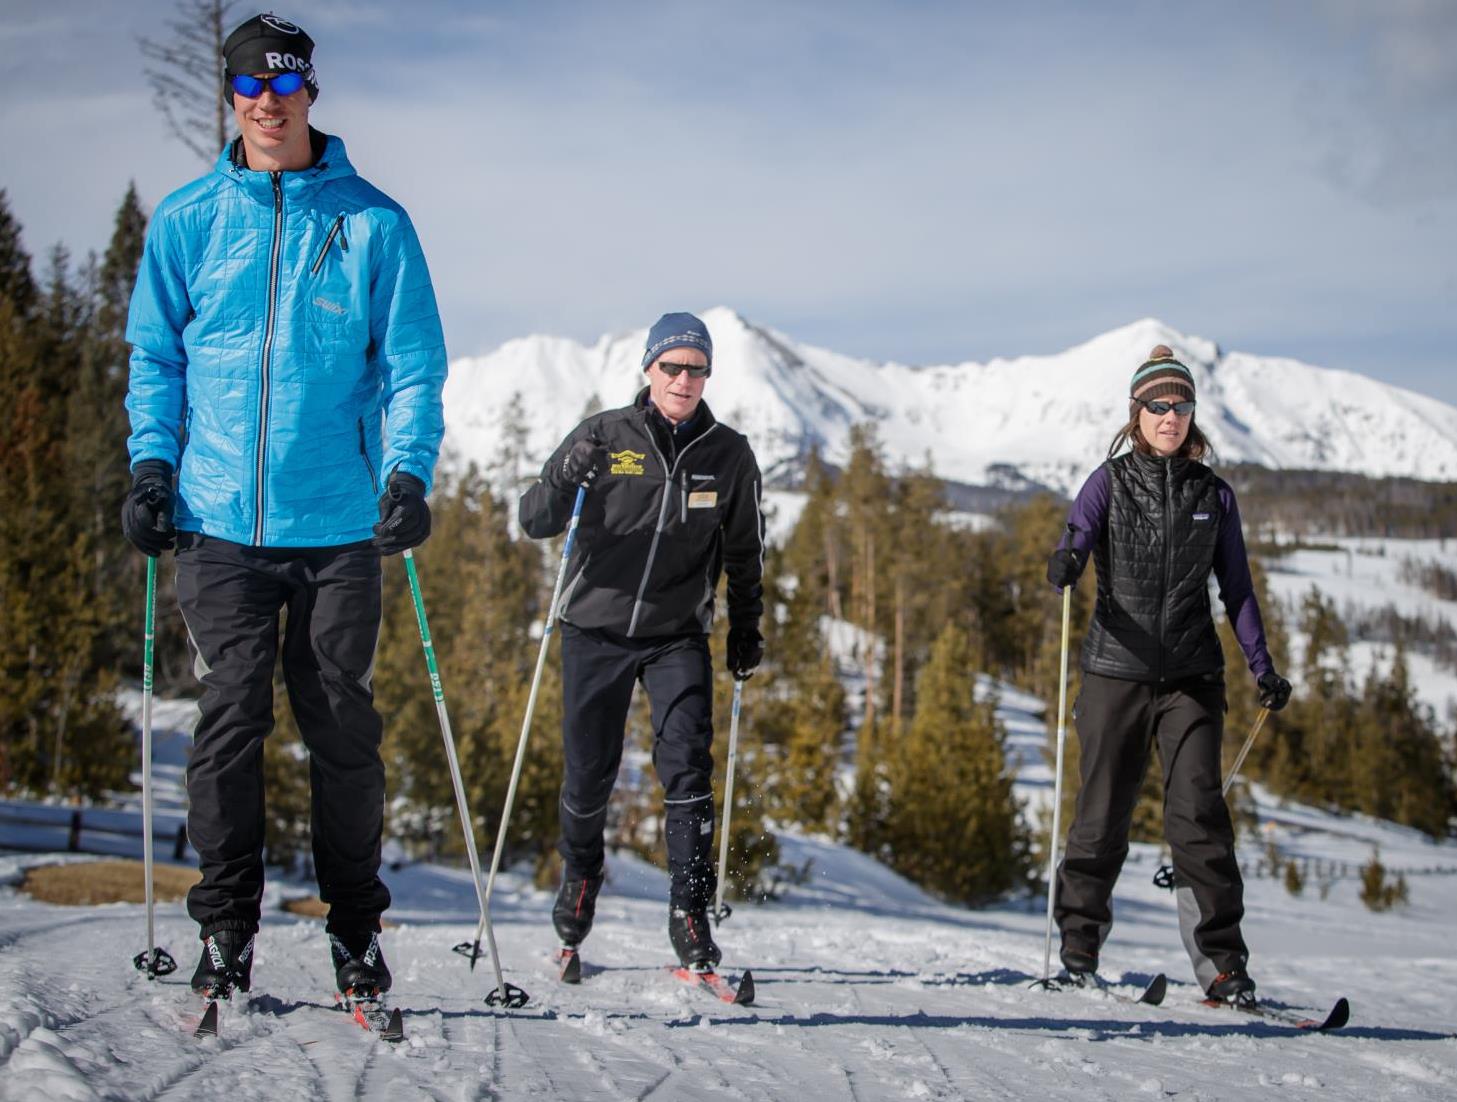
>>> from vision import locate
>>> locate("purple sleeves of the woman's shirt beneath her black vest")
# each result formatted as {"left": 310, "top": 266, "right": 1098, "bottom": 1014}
{"left": 1058, "top": 466, "right": 1275, "bottom": 678}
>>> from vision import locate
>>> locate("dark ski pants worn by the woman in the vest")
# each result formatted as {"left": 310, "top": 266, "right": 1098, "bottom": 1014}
{"left": 1056, "top": 673, "right": 1249, "bottom": 985}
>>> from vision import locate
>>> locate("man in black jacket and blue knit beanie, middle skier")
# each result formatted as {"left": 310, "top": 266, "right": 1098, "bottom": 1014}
{"left": 520, "top": 313, "right": 763, "bottom": 968}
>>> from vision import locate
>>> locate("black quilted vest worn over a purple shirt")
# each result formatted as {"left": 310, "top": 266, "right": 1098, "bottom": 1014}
{"left": 1083, "top": 452, "right": 1224, "bottom": 682}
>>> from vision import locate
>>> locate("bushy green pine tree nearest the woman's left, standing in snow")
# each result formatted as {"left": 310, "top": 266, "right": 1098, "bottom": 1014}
{"left": 886, "top": 625, "right": 1029, "bottom": 904}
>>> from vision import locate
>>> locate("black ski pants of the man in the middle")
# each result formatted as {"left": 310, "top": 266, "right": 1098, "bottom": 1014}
{"left": 558, "top": 622, "right": 718, "bottom": 910}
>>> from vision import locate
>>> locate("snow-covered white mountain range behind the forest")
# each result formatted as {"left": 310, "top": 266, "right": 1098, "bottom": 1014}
{"left": 446, "top": 306, "right": 1457, "bottom": 493}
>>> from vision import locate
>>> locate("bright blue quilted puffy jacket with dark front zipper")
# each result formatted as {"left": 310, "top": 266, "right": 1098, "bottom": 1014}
{"left": 127, "top": 134, "right": 446, "bottom": 547}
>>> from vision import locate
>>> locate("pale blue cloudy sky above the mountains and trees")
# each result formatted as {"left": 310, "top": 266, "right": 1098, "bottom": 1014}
{"left": 0, "top": 0, "right": 1457, "bottom": 402}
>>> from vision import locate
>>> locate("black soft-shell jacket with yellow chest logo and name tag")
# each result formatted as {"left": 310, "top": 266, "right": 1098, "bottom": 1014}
{"left": 520, "top": 388, "right": 763, "bottom": 638}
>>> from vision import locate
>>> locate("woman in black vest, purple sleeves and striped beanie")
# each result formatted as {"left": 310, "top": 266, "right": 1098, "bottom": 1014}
{"left": 1048, "top": 344, "right": 1289, "bottom": 1000}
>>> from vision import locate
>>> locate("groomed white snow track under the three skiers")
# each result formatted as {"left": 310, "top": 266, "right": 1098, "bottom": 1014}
{"left": 0, "top": 838, "right": 1457, "bottom": 1102}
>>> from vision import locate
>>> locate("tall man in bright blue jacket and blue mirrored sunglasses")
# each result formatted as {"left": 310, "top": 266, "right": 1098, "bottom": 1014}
{"left": 122, "top": 15, "right": 446, "bottom": 997}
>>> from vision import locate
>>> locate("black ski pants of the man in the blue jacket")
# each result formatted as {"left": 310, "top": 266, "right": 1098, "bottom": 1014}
{"left": 176, "top": 532, "right": 389, "bottom": 937}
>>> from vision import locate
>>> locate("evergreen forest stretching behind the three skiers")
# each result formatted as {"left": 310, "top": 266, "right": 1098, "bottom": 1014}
{"left": 0, "top": 189, "right": 1457, "bottom": 905}
